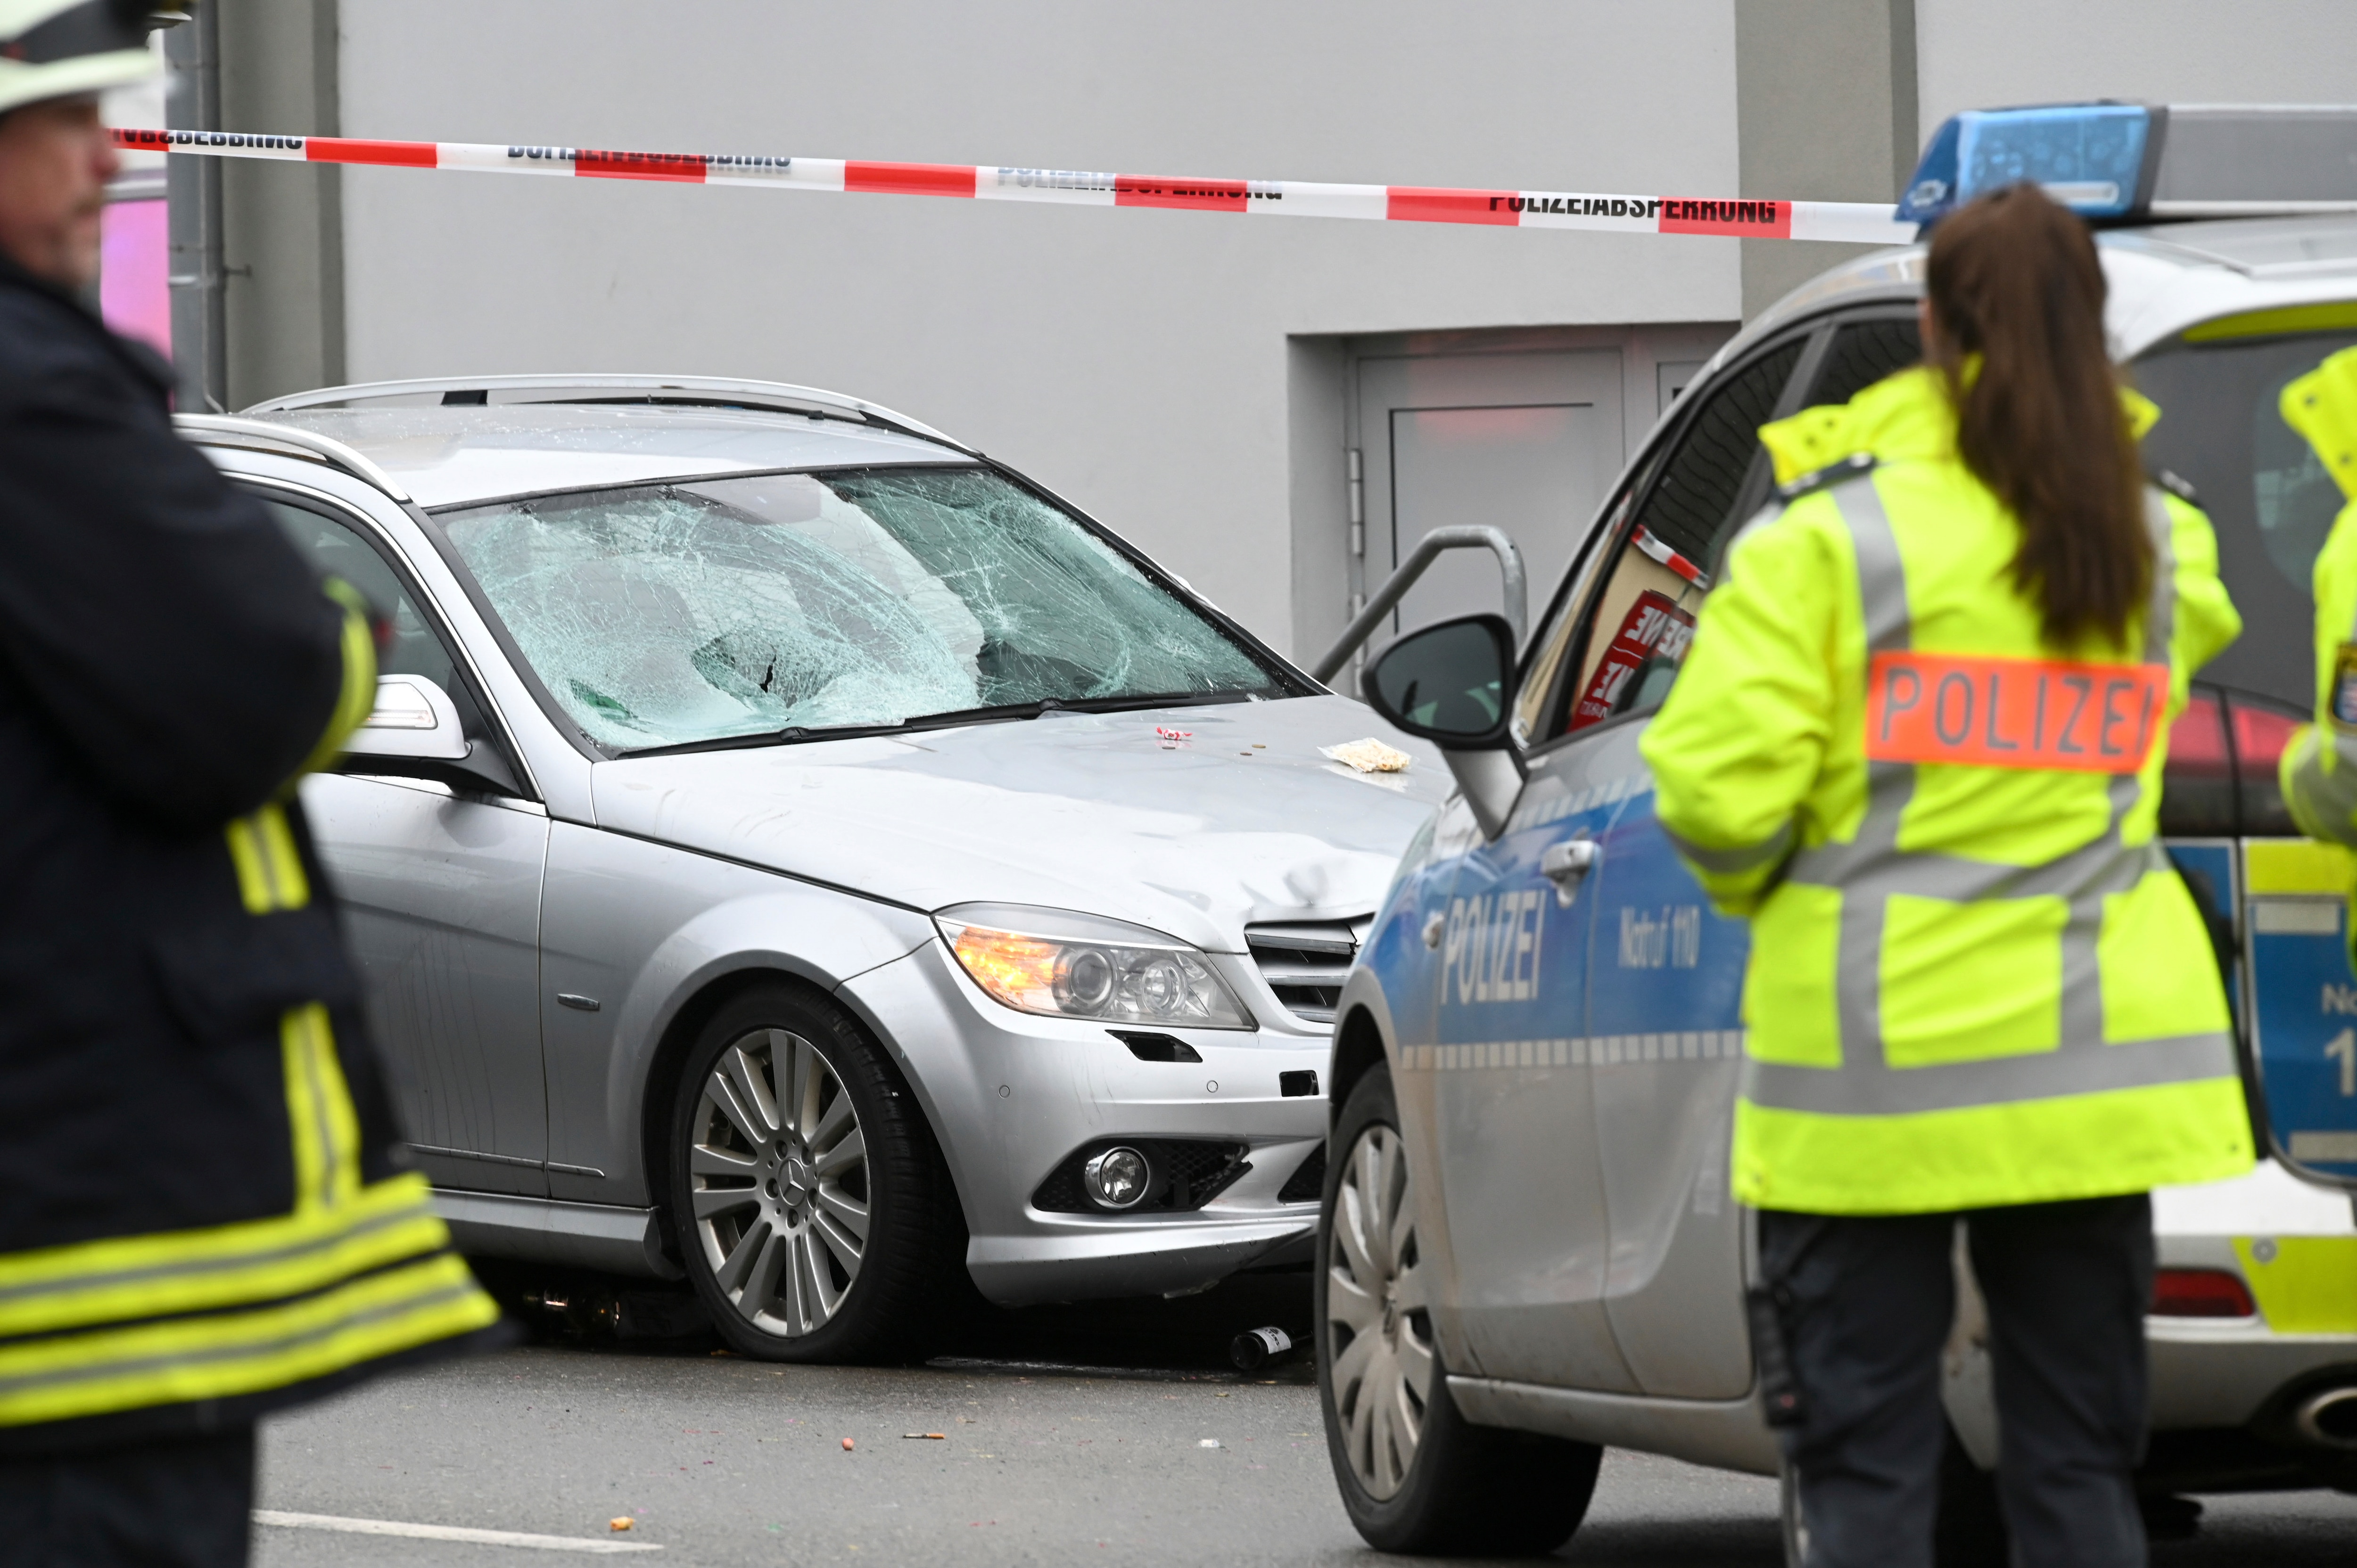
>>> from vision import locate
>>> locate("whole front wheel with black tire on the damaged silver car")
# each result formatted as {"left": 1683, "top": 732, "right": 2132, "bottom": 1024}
{"left": 669, "top": 983, "right": 971, "bottom": 1363}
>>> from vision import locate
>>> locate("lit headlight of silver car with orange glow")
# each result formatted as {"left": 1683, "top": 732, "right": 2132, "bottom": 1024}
{"left": 933, "top": 903, "right": 1254, "bottom": 1028}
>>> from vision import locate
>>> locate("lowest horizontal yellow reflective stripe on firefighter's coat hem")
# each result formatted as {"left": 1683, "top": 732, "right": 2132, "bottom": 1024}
{"left": 0, "top": 1252, "right": 500, "bottom": 1427}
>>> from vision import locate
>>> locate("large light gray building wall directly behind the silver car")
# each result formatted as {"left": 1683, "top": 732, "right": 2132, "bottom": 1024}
{"left": 328, "top": 0, "right": 1742, "bottom": 656}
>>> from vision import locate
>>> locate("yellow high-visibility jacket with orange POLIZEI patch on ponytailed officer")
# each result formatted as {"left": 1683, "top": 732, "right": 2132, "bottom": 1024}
{"left": 1643, "top": 368, "right": 2253, "bottom": 1215}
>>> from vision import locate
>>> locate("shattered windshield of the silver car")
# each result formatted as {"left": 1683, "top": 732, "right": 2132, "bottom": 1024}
{"left": 441, "top": 467, "right": 1287, "bottom": 750}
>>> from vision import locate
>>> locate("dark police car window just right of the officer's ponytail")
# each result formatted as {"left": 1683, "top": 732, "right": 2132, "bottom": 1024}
{"left": 2133, "top": 332, "right": 2357, "bottom": 710}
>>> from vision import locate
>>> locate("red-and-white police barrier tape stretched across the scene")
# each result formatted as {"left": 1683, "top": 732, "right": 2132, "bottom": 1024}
{"left": 115, "top": 130, "right": 1916, "bottom": 245}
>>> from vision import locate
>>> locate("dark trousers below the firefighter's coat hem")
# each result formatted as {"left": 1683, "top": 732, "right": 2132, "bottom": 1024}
{"left": 0, "top": 1427, "right": 255, "bottom": 1568}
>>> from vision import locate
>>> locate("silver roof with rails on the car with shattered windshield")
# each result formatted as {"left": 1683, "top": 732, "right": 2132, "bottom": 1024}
{"left": 227, "top": 377, "right": 976, "bottom": 507}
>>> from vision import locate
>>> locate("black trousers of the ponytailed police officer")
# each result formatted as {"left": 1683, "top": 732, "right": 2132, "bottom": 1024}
{"left": 1761, "top": 1193, "right": 2152, "bottom": 1568}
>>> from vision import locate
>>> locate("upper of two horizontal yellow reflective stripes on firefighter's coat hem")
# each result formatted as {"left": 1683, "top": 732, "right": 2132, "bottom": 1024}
{"left": 0, "top": 1172, "right": 450, "bottom": 1337}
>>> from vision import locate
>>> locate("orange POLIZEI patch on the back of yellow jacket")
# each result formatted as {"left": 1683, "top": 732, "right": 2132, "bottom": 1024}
{"left": 1867, "top": 653, "right": 2168, "bottom": 773}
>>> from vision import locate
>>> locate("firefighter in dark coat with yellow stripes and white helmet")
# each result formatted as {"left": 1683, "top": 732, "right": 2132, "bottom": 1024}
{"left": 0, "top": 0, "right": 497, "bottom": 1568}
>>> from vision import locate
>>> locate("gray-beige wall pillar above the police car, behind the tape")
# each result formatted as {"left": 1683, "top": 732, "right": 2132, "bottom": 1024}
{"left": 1735, "top": 0, "right": 1919, "bottom": 320}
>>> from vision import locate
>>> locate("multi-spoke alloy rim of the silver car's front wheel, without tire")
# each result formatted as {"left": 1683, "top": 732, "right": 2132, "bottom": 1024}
{"left": 688, "top": 1028, "right": 870, "bottom": 1337}
